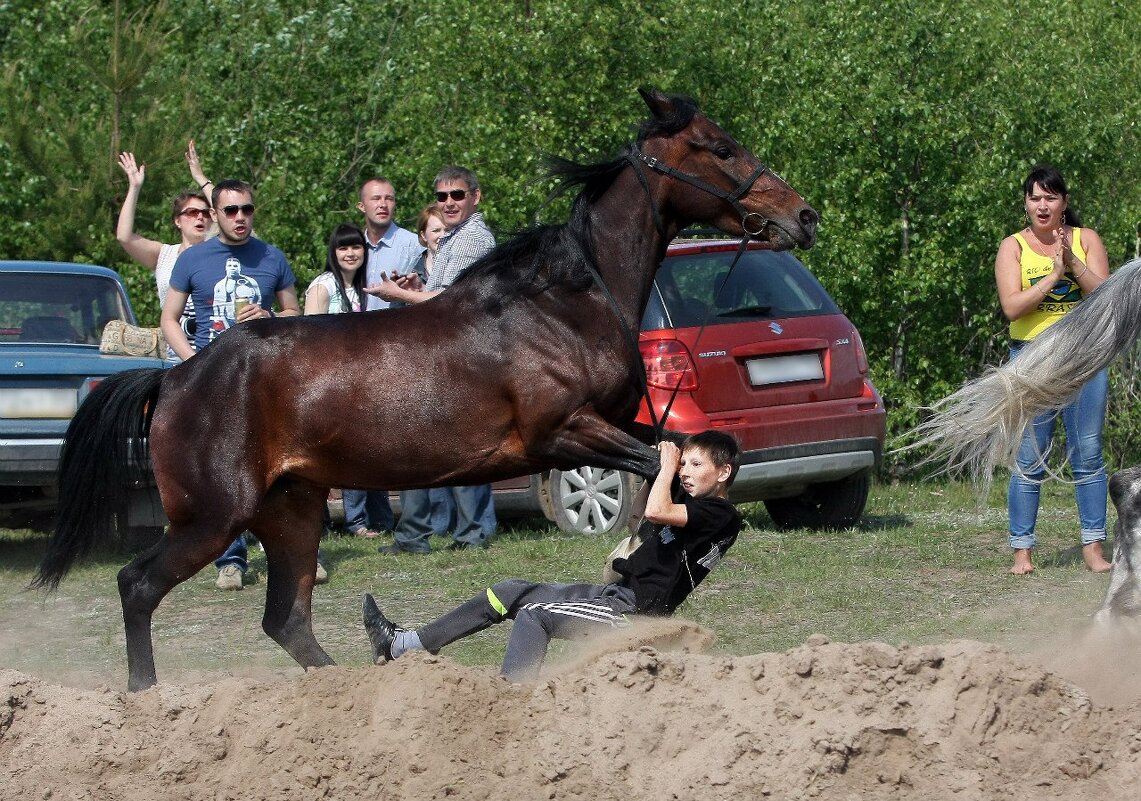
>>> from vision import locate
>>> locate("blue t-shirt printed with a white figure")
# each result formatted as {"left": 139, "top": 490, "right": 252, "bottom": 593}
{"left": 170, "top": 237, "right": 297, "bottom": 350}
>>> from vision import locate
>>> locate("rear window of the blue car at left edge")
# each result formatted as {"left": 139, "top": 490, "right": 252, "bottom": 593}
{"left": 0, "top": 273, "right": 133, "bottom": 345}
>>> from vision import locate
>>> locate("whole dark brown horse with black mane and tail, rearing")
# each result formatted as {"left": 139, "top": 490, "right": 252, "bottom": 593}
{"left": 37, "top": 86, "right": 818, "bottom": 690}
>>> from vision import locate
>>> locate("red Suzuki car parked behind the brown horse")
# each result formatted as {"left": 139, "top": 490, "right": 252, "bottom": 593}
{"left": 493, "top": 240, "right": 887, "bottom": 533}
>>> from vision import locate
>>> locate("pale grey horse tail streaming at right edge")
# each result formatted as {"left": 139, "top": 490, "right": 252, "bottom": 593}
{"left": 898, "top": 259, "right": 1141, "bottom": 483}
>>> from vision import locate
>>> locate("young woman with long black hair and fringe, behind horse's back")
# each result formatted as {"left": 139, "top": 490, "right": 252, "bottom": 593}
{"left": 305, "top": 223, "right": 381, "bottom": 543}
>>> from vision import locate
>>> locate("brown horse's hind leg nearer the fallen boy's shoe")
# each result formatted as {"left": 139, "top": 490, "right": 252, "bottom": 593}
{"left": 252, "top": 479, "right": 334, "bottom": 669}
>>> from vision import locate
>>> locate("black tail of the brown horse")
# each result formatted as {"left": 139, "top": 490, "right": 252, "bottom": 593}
{"left": 32, "top": 367, "right": 165, "bottom": 590}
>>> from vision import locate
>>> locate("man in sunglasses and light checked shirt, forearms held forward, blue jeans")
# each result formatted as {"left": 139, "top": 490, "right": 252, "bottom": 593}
{"left": 365, "top": 167, "right": 495, "bottom": 555}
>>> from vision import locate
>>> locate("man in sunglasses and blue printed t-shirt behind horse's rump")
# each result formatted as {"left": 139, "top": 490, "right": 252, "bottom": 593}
{"left": 161, "top": 180, "right": 303, "bottom": 590}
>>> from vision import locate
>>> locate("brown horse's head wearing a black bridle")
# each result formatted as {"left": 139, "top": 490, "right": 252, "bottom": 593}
{"left": 628, "top": 89, "right": 820, "bottom": 250}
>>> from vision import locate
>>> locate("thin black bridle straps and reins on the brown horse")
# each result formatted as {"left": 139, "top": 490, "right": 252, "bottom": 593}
{"left": 586, "top": 145, "right": 770, "bottom": 444}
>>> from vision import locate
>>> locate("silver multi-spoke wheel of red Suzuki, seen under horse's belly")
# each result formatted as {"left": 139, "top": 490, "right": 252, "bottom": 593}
{"left": 548, "top": 467, "right": 633, "bottom": 534}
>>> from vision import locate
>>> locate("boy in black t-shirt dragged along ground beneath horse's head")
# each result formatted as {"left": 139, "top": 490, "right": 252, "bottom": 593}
{"left": 364, "top": 431, "right": 741, "bottom": 681}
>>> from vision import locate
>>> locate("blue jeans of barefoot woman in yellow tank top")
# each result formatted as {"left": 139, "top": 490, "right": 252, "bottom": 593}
{"left": 1006, "top": 347, "right": 1109, "bottom": 550}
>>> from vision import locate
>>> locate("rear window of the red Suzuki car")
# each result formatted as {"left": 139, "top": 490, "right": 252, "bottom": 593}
{"left": 642, "top": 249, "right": 840, "bottom": 330}
